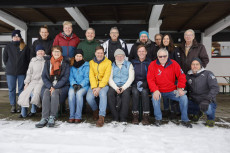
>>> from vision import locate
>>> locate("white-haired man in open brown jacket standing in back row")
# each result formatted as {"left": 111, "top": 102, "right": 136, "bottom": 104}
{"left": 179, "top": 29, "right": 209, "bottom": 73}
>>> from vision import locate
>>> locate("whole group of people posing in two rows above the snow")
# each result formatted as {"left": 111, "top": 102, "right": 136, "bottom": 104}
{"left": 3, "top": 21, "right": 219, "bottom": 128}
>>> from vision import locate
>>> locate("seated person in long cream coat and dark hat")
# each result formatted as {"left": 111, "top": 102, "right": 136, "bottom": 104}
{"left": 18, "top": 45, "right": 45, "bottom": 118}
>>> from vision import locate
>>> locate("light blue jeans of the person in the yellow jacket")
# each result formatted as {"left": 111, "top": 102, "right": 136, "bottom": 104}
{"left": 86, "top": 86, "right": 109, "bottom": 117}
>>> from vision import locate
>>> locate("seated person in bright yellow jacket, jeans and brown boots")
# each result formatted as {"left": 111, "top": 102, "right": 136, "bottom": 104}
{"left": 86, "top": 46, "right": 112, "bottom": 127}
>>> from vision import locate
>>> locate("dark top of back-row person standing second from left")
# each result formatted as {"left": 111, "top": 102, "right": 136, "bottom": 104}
{"left": 30, "top": 37, "right": 53, "bottom": 58}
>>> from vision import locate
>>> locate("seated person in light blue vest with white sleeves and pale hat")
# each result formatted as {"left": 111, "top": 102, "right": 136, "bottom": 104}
{"left": 108, "top": 49, "right": 134, "bottom": 124}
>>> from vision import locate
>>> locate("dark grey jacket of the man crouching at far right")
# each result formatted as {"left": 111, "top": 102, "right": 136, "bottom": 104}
{"left": 186, "top": 68, "right": 219, "bottom": 104}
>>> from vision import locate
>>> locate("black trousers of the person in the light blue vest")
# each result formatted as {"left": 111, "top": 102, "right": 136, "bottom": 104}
{"left": 108, "top": 87, "right": 131, "bottom": 122}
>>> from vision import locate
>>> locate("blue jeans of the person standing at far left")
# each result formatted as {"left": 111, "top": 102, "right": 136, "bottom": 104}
{"left": 6, "top": 75, "right": 26, "bottom": 105}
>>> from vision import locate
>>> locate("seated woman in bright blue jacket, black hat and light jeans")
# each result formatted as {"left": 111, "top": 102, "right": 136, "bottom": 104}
{"left": 68, "top": 49, "right": 89, "bottom": 123}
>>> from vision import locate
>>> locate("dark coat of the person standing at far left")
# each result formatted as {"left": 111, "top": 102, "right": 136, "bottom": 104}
{"left": 3, "top": 41, "right": 30, "bottom": 75}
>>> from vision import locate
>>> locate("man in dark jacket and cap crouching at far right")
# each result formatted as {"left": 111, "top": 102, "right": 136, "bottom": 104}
{"left": 187, "top": 58, "right": 219, "bottom": 127}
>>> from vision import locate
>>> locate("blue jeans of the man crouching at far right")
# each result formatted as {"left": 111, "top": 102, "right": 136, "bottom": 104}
{"left": 188, "top": 100, "right": 217, "bottom": 120}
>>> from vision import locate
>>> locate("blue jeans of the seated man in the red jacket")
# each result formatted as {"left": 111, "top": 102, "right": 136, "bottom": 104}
{"left": 152, "top": 91, "right": 189, "bottom": 122}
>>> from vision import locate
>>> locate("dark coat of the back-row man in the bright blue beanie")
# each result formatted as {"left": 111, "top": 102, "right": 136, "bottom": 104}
{"left": 129, "top": 39, "right": 157, "bottom": 61}
